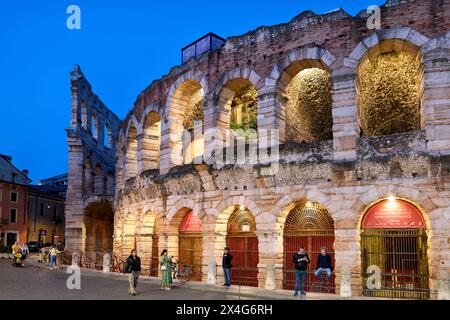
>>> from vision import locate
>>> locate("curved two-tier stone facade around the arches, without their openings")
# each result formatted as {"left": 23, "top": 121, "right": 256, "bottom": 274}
{"left": 68, "top": 0, "right": 450, "bottom": 299}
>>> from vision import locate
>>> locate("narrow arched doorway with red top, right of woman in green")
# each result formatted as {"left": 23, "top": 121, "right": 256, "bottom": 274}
{"left": 178, "top": 210, "right": 203, "bottom": 281}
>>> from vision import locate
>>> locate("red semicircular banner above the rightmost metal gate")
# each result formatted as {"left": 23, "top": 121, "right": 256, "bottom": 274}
{"left": 362, "top": 199, "right": 425, "bottom": 229}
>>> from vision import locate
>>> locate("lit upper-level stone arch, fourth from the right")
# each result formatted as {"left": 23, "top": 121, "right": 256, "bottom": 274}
{"left": 161, "top": 71, "right": 208, "bottom": 173}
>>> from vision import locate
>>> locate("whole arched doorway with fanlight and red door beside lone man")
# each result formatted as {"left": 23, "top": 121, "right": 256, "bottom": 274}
{"left": 226, "top": 207, "right": 259, "bottom": 287}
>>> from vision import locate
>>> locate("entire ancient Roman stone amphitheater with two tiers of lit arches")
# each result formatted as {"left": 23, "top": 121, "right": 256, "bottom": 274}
{"left": 66, "top": 0, "right": 450, "bottom": 299}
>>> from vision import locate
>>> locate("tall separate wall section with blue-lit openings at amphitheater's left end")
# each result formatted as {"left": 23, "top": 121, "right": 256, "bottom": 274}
{"left": 65, "top": 66, "right": 120, "bottom": 251}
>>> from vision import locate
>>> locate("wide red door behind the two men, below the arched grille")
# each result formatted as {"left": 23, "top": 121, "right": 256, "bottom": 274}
{"left": 283, "top": 234, "right": 335, "bottom": 293}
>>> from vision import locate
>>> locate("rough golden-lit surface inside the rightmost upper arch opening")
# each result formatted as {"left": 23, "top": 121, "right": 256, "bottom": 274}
{"left": 358, "top": 52, "right": 421, "bottom": 136}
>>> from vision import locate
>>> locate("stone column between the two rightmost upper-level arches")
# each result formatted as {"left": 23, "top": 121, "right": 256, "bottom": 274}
{"left": 332, "top": 69, "right": 360, "bottom": 161}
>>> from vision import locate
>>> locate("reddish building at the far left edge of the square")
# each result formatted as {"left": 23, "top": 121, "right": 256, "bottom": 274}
{"left": 0, "top": 154, "right": 31, "bottom": 246}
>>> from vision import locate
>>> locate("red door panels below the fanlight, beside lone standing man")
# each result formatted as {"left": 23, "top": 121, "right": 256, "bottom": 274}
{"left": 227, "top": 235, "right": 259, "bottom": 287}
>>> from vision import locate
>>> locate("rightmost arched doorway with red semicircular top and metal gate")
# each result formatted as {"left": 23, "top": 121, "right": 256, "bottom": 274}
{"left": 361, "top": 198, "right": 430, "bottom": 299}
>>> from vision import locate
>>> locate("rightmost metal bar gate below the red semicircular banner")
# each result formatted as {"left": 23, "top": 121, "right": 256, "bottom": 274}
{"left": 361, "top": 229, "right": 430, "bottom": 300}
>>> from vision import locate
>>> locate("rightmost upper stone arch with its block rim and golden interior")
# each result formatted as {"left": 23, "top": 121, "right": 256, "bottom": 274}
{"left": 345, "top": 27, "right": 429, "bottom": 136}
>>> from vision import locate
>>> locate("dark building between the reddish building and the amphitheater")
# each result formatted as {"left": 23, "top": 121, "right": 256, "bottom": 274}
{"left": 28, "top": 174, "right": 67, "bottom": 243}
